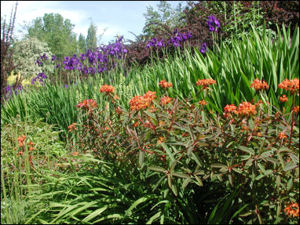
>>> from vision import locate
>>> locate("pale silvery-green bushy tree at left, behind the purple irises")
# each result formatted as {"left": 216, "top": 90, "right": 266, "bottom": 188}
{"left": 13, "top": 37, "right": 53, "bottom": 79}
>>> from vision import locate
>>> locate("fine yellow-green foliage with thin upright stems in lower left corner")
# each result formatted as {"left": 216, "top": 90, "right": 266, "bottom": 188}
{"left": 1, "top": 117, "right": 65, "bottom": 224}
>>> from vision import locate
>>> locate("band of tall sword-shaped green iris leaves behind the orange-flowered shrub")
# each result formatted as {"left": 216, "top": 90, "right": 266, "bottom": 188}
{"left": 1, "top": 24, "right": 299, "bottom": 139}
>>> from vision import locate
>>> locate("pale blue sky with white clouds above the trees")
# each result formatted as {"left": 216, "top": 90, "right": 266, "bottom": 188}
{"left": 1, "top": 1, "right": 185, "bottom": 44}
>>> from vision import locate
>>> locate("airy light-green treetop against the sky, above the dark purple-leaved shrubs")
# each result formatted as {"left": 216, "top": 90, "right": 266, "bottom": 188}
{"left": 143, "top": 1, "right": 184, "bottom": 37}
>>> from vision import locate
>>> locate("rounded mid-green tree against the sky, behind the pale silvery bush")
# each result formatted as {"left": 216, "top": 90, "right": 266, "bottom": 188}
{"left": 26, "top": 13, "right": 77, "bottom": 57}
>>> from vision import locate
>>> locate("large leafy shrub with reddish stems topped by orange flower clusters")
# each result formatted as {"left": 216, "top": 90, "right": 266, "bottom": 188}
{"left": 62, "top": 79, "right": 299, "bottom": 223}
